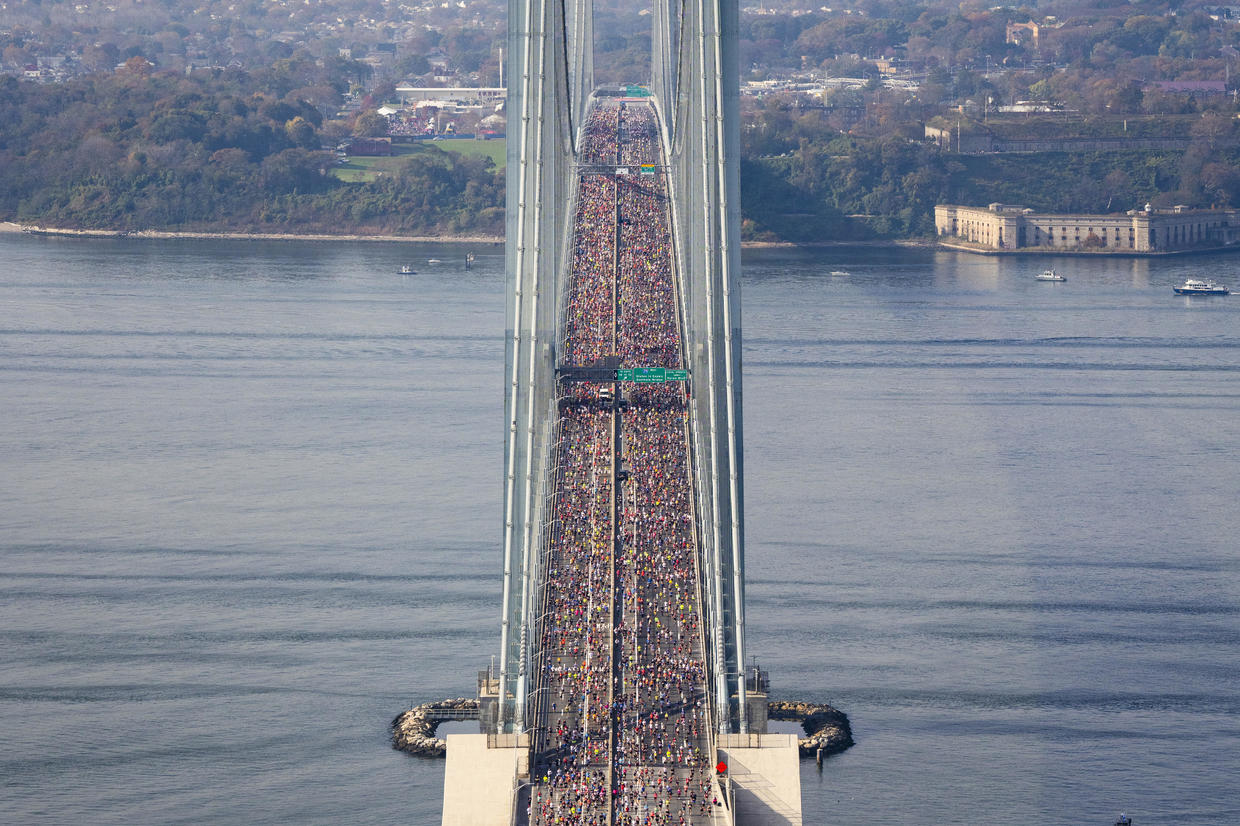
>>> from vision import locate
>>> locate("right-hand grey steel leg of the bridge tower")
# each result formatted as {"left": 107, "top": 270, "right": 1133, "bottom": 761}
{"left": 653, "top": 0, "right": 749, "bottom": 734}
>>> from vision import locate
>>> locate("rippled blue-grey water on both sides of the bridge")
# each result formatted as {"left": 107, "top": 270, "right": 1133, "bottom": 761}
{"left": 0, "top": 236, "right": 1240, "bottom": 826}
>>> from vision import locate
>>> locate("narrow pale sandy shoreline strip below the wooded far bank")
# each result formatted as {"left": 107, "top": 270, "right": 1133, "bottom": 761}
{"left": 0, "top": 221, "right": 937, "bottom": 249}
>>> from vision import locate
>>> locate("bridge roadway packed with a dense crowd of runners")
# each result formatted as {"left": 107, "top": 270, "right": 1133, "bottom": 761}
{"left": 522, "top": 99, "right": 722, "bottom": 826}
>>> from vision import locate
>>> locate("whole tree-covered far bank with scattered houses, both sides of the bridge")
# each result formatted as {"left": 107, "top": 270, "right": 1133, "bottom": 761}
{"left": 12, "top": 0, "right": 1240, "bottom": 242}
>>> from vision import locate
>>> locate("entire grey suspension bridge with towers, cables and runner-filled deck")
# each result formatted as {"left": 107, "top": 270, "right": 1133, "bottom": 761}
{"left": 443, "top": 0, "right": 801, "bottom": 826}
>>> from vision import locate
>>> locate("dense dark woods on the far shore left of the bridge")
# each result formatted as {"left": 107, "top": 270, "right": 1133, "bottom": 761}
{"left": 0, "top": 68, "right": 503, "bottom": 234}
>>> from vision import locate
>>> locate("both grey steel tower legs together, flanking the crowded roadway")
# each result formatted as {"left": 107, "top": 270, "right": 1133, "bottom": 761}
{"left": 492, "top": 0, "right": 748, "bottom": 733}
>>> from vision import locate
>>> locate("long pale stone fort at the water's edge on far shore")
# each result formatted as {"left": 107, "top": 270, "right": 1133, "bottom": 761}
{"left": 934, "top": 203, "right": 1240, "bottom": 253}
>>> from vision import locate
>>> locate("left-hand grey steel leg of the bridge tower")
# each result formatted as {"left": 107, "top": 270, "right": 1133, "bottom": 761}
{"left": 496, "top": 0, "right": 582, "bottom": 733}
